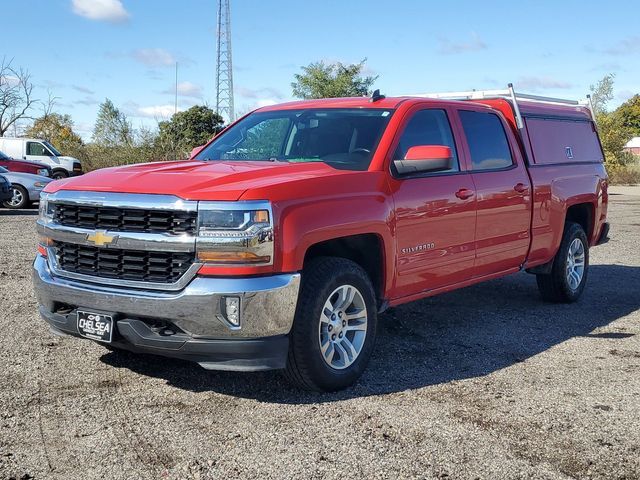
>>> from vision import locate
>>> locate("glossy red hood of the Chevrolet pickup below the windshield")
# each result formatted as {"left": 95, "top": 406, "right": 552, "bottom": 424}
{"left": 45, "top": 161, "right": 356, "bottom": 201}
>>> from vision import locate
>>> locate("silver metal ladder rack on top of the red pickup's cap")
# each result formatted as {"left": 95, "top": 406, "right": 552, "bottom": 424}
{"left": 408, "top": 83, "right": 596, "bottom": 130}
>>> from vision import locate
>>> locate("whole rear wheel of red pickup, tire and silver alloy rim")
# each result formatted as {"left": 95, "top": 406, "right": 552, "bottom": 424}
{"left": 536, "top": 222, "right": 589, "bottom": 303}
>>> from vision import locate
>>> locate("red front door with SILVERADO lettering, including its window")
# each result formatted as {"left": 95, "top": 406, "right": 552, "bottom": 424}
{"left": 390, "top": 106, "right": 476, "bottom": 297}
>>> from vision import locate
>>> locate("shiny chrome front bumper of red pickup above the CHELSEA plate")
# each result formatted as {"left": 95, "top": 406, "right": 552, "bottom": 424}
{"left": 33, "top": 255, "right": 300, "bottom": 339}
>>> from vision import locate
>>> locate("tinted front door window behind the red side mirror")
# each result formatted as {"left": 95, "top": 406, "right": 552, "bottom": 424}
{"left": 393, "top": 109, "right": 460, "bottom": 174}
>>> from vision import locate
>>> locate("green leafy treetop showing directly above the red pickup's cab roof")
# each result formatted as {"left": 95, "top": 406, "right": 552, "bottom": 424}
{"left": 291, "top": 58, "right": 378, "bottom": 99}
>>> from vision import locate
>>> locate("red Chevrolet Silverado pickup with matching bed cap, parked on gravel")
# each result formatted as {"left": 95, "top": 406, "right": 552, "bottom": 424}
{"left": 34, "top": 87, "right": 609, "bottom": 391}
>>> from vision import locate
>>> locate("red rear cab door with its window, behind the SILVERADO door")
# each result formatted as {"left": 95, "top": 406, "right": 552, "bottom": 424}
{"left": 458, "top": 106, "right": 531, "bottom": 276}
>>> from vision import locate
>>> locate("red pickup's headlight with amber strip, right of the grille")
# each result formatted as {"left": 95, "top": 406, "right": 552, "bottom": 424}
{"left": 196, "top": 202, "right": 273, "bottom": 265}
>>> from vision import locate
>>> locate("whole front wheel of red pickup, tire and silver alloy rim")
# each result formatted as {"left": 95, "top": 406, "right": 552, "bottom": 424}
{"left": 286, "top": 257, "right": 377, "bottom": 392}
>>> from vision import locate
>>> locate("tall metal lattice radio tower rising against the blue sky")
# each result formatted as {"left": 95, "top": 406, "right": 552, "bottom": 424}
{"left": 216, "top": 0, "right": 235, "bottom": 122}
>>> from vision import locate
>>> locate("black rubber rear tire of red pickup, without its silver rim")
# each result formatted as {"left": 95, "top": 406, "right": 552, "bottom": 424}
{"left": 536, "top": 222, "right": 589, "bottom": 303}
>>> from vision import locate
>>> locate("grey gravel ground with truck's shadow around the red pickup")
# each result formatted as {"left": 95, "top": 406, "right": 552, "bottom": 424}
{"left": 0, "top": 187, "right": 640, "bottom": 479}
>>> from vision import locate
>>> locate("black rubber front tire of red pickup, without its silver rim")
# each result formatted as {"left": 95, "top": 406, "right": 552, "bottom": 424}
{"left": 285, "top": 257, "right": 377, "bottom": 392}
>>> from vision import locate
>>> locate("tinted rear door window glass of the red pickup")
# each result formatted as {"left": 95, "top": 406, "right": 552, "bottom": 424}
{"left": 459, "top": 110, "right": 513, "bottom": 170}
